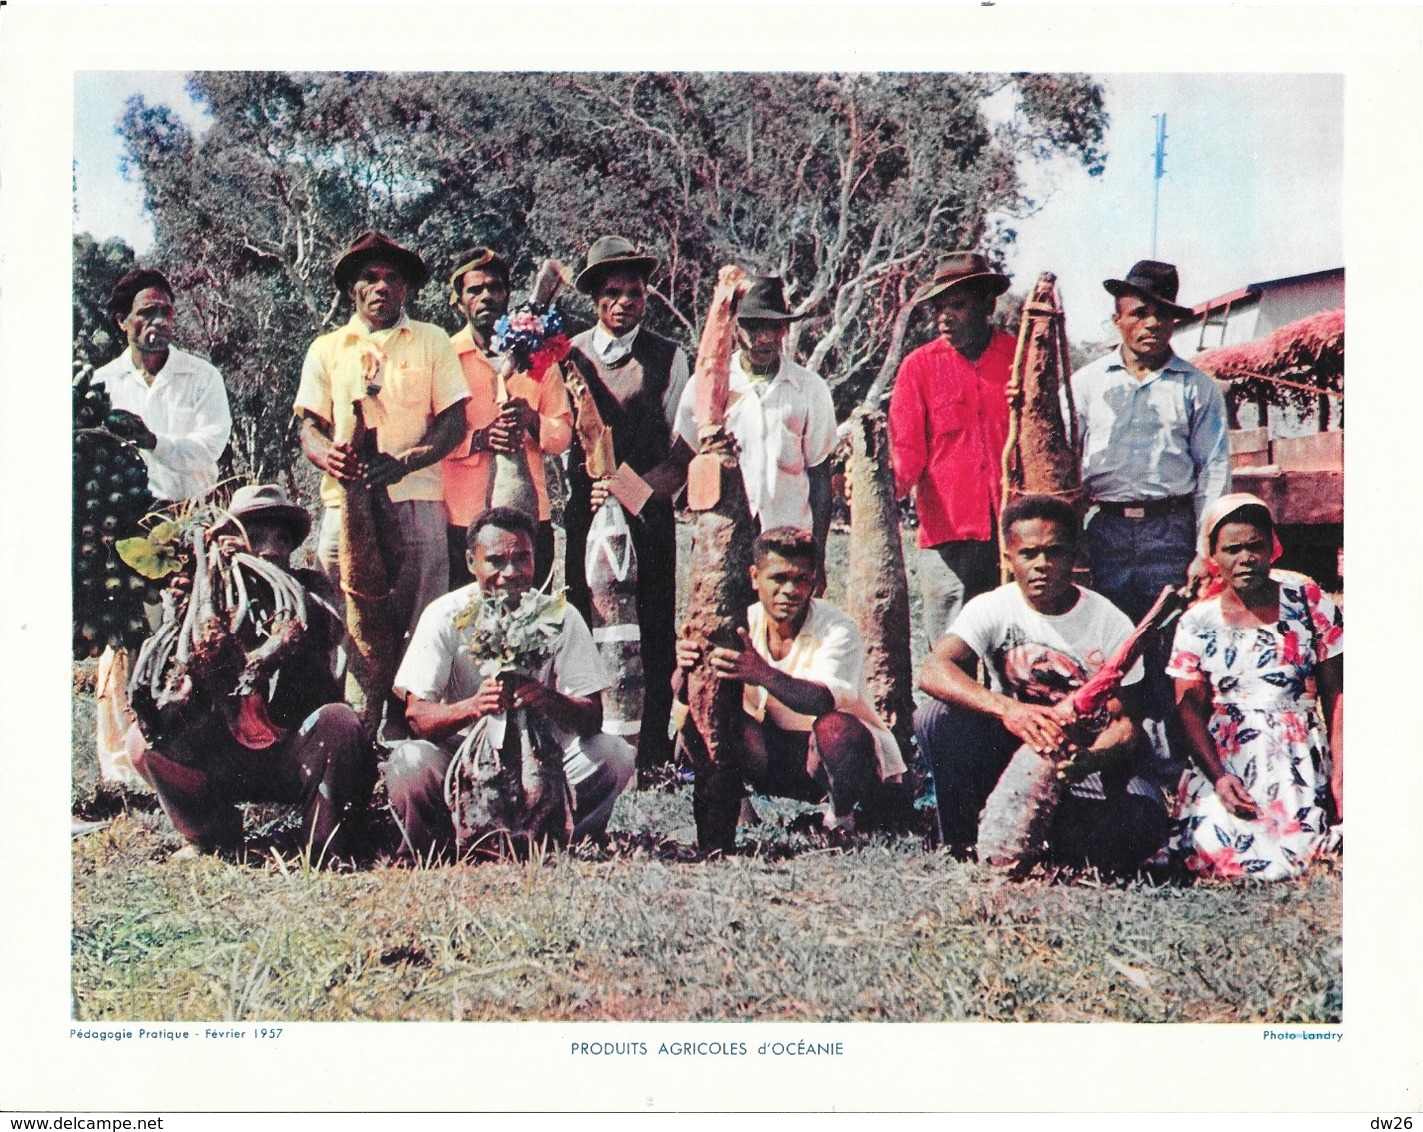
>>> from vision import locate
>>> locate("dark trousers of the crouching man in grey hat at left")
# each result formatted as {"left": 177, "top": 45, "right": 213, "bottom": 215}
{"left": 128, "top": 704, "right": 376, "bottom": 862}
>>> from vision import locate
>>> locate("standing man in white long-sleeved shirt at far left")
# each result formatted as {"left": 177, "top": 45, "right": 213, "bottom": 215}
{"left": 94, "top": 269, "right": 232, "bottom": 502}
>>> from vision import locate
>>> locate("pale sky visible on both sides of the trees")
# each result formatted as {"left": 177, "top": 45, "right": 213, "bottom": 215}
{"left": 74, "top": 71, "right": 1343, "bottom": 341}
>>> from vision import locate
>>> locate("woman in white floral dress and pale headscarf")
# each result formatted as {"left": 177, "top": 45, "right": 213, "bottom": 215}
{"left": 1167, "top": 495, "right": 1343, "bottom": 880}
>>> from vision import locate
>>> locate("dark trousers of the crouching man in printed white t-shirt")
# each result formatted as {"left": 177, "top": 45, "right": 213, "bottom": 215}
{"left": 914, "top": 700, "right": 1168, "bottom": 873}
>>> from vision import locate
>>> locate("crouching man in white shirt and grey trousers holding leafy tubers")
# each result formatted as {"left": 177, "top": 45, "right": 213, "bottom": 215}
{"left": 381, "top": 508, "right": 635, "bottom": 860}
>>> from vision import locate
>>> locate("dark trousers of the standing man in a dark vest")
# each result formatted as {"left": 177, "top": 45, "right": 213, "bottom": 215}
{"left": 564, "top": 492, "right": 677, "bottom": 771}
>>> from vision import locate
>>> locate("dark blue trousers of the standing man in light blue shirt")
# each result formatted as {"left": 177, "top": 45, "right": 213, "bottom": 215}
{"left": 1087, "top": 508, "right": 1195, "bottom": 792}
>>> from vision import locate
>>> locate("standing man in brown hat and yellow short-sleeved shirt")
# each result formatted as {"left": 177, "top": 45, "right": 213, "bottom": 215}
{"left": 295, "top": 232, "right": 470, "bottom": 631}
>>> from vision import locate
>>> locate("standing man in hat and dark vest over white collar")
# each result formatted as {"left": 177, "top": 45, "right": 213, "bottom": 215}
{"left": 564, "top": 236, "right": 693, "bottom": 774}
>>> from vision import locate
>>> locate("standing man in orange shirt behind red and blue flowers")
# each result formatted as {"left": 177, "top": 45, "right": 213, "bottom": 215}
{"left": 444, "top": 247, "right": 573, "bottom": 589}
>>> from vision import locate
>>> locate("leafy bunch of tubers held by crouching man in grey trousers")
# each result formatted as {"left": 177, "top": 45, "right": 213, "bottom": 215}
{"left": 445, "top": 589, "right": 573, "bottom": 856}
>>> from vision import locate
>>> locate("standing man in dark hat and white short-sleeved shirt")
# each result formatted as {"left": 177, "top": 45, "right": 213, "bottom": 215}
{"left": 677, "top": 276, "right": 835, "bottom": 577}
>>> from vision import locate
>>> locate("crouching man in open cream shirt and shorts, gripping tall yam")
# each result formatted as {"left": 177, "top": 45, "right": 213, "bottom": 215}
{"left": 676, "top": 526, "right": 905, "bottom": 852}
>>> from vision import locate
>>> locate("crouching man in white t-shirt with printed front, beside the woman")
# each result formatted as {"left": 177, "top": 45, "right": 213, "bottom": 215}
{"left": 914, "top": 495, "right": 1167, "bottom": 873}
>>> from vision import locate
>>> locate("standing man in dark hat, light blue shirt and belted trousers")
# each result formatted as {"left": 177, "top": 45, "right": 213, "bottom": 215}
{"left": 1072, "top": 259, "right": 1231, "bottom": 786}
